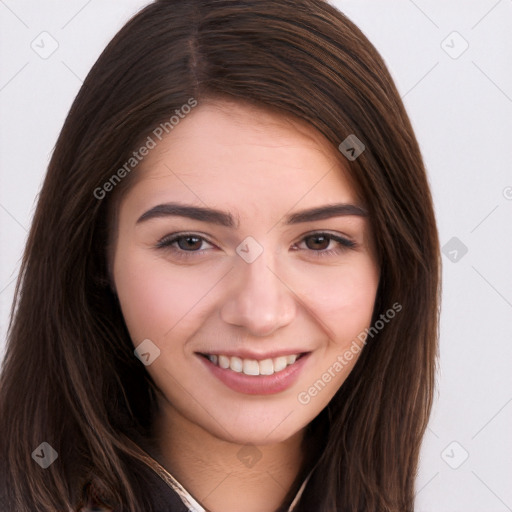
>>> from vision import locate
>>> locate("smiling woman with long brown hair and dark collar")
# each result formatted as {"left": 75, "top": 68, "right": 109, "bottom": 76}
{"left": 0, "top": 0, "right": 439, "bottom": 512}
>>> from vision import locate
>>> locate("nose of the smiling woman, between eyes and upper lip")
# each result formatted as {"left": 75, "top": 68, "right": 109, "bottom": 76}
{"left": 221, "top": 251, "right": 297, "bottom": 336}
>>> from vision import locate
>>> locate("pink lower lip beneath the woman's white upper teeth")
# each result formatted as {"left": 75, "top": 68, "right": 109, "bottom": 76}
{"left": 198, "top": 353, "right": 309, "bottom": 395}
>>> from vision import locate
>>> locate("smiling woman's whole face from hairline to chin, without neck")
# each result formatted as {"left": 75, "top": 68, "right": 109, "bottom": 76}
{"left": 113, "top": 102, "right": 379, "bottom": 445}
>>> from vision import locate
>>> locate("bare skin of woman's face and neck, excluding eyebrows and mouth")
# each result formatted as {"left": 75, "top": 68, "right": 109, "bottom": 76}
{"left": 112, "top": 101, "right": 379, "bottom": 512}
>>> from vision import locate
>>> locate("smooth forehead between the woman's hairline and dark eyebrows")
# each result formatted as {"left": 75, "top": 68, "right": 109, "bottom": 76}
{"left": 121, "top": 102, "right": 361, "bottom": 214}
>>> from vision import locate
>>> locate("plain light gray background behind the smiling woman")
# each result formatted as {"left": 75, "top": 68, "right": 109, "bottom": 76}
{"left": 0, "top": 0, "right": 512, "bottom": 512}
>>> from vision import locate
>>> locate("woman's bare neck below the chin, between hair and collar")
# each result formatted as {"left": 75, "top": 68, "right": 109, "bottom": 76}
{"left": 154, "top": 405, "right": 305, "bottom": 512}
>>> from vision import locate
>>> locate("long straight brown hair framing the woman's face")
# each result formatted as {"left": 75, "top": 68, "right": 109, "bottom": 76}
{"left": 0, "top": 0, "right": 440, "bottom": 512}
